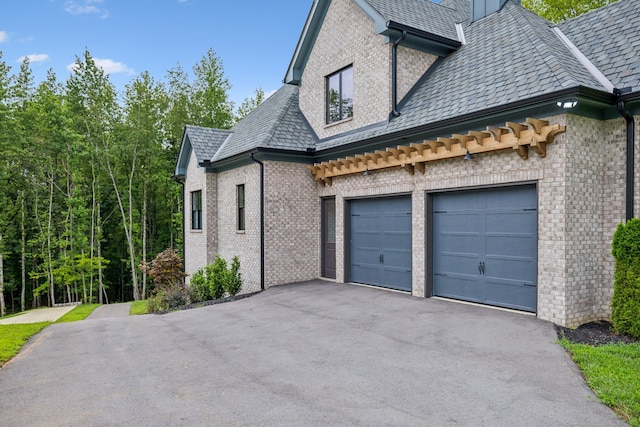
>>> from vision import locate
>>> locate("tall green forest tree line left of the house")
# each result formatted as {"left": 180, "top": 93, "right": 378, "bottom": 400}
{"left": 0, "top": 49, "right": 264, "bottom": 316}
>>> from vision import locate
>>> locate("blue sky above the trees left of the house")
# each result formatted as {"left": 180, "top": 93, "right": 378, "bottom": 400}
{"left": 0, "top": 0, "right": 312, "bottom": 106}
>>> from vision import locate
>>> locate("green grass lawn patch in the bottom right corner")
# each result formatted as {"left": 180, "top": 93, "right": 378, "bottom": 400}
{"left": 560, "top": 339, "right": 640, "bottom": 427}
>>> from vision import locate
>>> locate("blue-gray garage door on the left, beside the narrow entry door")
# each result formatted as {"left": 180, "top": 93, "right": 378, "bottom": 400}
{"left": 350, "top": 196, "right": 411, "bottom": 291}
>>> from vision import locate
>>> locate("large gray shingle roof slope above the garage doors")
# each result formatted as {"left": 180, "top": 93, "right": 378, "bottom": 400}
{"left": 317, "top": 1, "right": 606, "bottom": 150}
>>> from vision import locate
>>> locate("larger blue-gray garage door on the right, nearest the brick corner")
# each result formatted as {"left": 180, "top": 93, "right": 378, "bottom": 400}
{"left": 433, "top": 185, "right": 538, "bottom": 312}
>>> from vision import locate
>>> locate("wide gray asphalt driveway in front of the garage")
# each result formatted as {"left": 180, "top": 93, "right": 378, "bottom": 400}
{"left": 0, "top": 281, "right": 625, "bottom": 426}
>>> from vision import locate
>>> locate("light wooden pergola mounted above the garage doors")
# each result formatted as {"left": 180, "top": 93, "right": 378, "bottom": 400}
{"left": 307, "top": 118, "right": 566, "bottom": 185}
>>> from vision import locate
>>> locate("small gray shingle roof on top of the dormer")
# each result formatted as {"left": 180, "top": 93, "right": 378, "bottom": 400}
{"left": 367, "top": 0, "right": 468, "bottom": 40}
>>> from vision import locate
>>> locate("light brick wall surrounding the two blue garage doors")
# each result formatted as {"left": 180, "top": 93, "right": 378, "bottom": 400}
{"left": 317, "top": 115, "right": 624, "bottom": 326}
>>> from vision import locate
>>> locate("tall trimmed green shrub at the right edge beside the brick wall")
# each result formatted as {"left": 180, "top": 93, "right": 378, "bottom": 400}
{"left": 611, "top": 218, "right": 640, "bottom": 338}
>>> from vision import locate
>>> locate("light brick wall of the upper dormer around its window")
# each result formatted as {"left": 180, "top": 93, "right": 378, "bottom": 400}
{"left": 300, "top": 0, "right": 436, "bottom": 138}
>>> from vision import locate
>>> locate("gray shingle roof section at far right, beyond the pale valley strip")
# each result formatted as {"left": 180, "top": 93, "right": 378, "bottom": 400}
{"left": 558, "top": 0, "right": 640, "bottom": 91}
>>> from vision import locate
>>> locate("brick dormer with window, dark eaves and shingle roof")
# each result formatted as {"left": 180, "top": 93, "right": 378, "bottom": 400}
{"left": 284, "top": 0, "right": 469, "bottom": 139}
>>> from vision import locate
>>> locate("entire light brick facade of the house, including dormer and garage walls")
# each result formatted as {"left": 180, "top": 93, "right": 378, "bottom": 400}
{"left": 178, "top": 0, "right": 640, "bottom": 326}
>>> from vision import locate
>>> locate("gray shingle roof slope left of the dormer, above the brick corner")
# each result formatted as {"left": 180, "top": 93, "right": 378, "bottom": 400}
{"left": 213, "top": 84, "right": 318, "bottom": 162}
